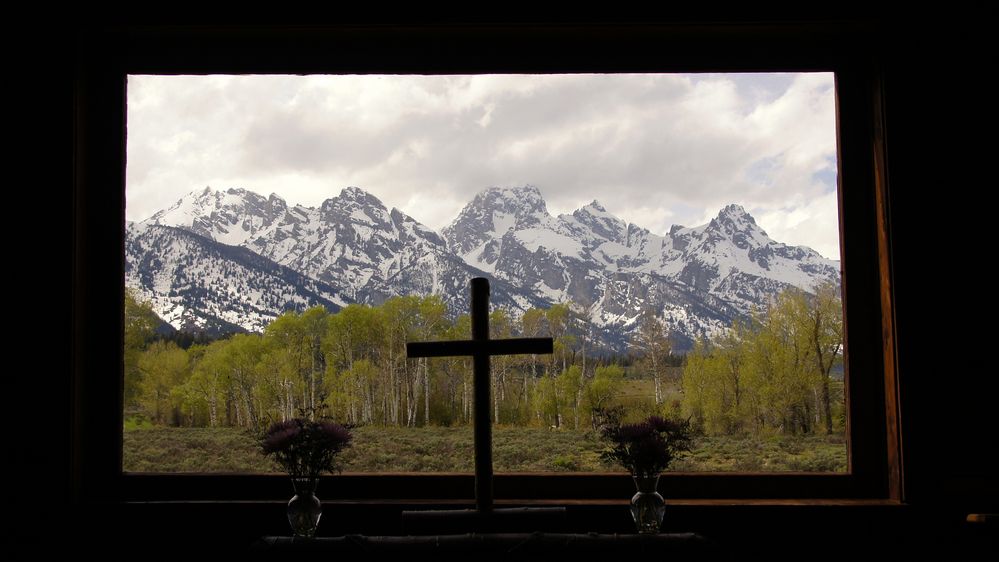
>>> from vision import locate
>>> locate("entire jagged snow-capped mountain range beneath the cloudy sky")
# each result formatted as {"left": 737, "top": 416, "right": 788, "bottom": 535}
{"left": 127, "top": 186, "right": 839, "bottom": 346}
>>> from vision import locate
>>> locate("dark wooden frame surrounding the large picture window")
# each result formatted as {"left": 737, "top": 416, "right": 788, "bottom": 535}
{"left": 73, "top": 22, "right": 902, "bottom": 503}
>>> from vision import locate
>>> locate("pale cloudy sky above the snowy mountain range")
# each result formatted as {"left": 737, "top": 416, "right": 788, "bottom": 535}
{"left": 126, "top": 73, "right": 839, "bottom": 259}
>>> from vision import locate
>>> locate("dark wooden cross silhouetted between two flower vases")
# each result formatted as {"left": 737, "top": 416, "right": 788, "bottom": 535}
{"left": 406, "top": 277, "right": 554, "bottom": 515}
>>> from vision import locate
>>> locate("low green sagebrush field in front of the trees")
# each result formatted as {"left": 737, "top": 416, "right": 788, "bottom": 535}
{"left": 123, "top": 426, "right": 847, "bottom": 472}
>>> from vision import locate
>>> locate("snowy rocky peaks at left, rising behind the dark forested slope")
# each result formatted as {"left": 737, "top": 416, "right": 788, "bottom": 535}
{"left": 141, "top": 187, "right": 450, "bottom": 294}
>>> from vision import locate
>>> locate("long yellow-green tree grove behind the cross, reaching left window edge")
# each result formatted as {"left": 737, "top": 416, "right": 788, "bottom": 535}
{"left": 125, "top": 288, "right": 675, "bottom": 428}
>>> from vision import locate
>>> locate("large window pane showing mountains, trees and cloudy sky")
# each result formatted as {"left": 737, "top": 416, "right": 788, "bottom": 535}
{"left": 123, "top": 72, "right": 847, "bottom": 472}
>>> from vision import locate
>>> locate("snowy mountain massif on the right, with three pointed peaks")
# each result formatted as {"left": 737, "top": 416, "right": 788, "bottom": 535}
{"left": 444, "top": 186, "right": 839, "bottom": 344}
